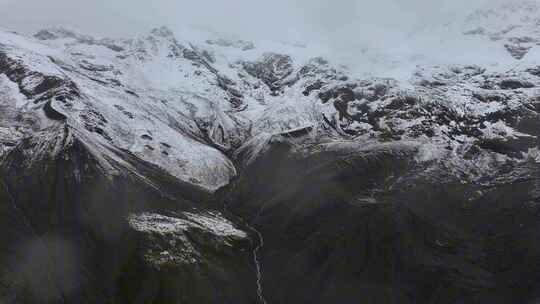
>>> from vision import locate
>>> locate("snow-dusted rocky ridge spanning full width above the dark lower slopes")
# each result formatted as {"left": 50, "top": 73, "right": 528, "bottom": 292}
{"left": 0, "top": 4, "right": 540, "bottom": 191}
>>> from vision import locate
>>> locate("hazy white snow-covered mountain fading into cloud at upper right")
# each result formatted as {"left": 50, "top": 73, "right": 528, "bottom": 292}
{"left": 348, "top": 1, "right": 540, "bottom": 80}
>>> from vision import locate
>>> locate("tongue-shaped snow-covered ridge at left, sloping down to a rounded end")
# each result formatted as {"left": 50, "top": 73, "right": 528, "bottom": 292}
{"left": 3, "top": 26, "right": 240, "bottom": 189}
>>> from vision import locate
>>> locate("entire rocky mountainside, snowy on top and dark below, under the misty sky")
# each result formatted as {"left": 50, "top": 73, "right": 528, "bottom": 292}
{"left": 0, "top": 2, "right": 540, "bottom": 303}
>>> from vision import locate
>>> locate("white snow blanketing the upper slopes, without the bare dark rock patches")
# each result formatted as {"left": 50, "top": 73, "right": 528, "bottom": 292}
{"left": 0, "top": 3, "right": 540, "bottom": 191}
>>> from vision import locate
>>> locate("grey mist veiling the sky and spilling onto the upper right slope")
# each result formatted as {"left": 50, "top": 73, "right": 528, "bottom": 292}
{"left": 0, "top": 0, "right": 540, "bottom": 77}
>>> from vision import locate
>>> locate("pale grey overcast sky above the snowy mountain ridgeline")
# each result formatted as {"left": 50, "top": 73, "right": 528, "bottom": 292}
{"left": 0, "top": 0, "right": 493, "bottom": 40}
